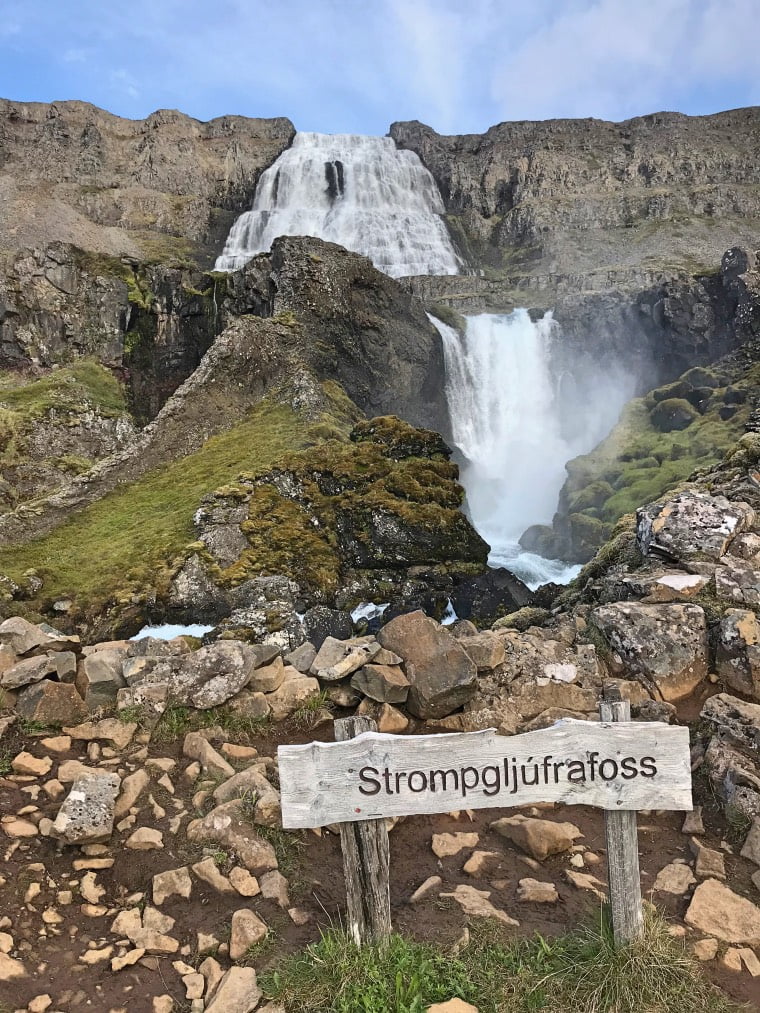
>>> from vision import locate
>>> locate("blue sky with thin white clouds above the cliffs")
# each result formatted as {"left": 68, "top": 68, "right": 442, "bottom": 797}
{"left": 0, "top": 0, "right": 760, "bottom": 134}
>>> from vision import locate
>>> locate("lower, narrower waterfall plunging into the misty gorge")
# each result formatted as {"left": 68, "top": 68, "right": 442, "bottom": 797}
{"left": 431, "top": 309, "right": 630, "bottom": 588}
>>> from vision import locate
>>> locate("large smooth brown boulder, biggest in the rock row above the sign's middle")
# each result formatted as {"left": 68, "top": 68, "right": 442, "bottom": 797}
{"left": 377, "top": 611, "right": 477, "bottom": 718}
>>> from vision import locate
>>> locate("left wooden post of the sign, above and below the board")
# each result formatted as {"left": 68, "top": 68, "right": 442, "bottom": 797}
{"left": 334, "top": 717, "right": 391, "bottom": 946}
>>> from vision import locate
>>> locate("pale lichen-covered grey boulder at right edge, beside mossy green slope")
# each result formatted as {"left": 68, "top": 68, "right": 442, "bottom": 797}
{"left": 636, "top": 490, "right": 754, "bottom": 563}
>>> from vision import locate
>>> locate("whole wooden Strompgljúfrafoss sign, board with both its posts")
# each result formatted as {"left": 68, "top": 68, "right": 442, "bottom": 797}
{"left": 278, "top": 692, "right": 692, "bottom": 944}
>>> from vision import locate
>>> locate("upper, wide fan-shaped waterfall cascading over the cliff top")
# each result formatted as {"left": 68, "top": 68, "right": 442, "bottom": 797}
{"left": 216, "top": 133, "right": 460, "bottom": 278}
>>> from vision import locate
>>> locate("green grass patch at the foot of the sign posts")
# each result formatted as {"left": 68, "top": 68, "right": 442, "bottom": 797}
{"left": 259, "top": 914, "right": 738, "bottom": 1013}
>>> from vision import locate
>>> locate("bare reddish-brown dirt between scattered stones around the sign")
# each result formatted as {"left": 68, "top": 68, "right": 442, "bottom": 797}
{"left": 0, "top": 725, "right": 760, "bottom": 1013}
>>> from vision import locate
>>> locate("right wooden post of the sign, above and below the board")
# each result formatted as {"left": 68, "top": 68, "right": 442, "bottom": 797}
{"left": 599, "top": 685, "right": 644, "bottom": 946}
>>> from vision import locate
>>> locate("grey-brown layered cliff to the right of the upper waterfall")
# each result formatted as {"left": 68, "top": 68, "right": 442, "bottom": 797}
{"left": 390, "top": 107, "right": 760, "bottom": 288}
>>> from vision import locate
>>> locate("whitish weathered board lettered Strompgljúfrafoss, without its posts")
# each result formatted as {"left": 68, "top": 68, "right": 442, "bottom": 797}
{"left": 278, "top": 720, "right": 692, "bottom": 828}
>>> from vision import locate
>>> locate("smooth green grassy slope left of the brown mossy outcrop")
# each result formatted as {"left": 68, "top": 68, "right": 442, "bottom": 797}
{"left": 0, "top": 401, "right": 305, "bottom": 605}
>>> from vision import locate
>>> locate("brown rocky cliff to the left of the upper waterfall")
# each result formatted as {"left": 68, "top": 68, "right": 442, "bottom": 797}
{"left": 0, "top": 100, "right": 295, "bottom": 266}
